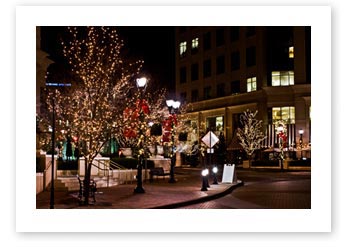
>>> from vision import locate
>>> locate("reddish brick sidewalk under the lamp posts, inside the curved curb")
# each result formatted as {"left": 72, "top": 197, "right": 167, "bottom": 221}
{"left": 36, "top": 167, "right": 243, "bottom": 209}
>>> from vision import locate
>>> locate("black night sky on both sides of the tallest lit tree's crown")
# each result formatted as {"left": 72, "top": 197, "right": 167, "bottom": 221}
{"left": 41, "top": 26, "right": 175, "bottom": 92}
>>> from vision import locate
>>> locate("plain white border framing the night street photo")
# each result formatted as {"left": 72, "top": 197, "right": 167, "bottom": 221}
{"left": 16, "top": 6, "right": 331, "bottom": 232}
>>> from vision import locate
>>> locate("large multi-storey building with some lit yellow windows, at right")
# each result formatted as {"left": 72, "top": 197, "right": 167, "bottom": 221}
{"left": 175, "top": 26, "right": 311, "bottom": 151}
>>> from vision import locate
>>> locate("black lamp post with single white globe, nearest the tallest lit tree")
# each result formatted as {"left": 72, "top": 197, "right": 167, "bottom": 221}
{"left": 134, "top": 77, "right": 147, "bottom": 193}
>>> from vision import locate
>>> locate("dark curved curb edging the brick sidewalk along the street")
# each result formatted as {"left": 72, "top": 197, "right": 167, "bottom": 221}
{"left": 149, "top": 180, "right": 244, "bottom": 209}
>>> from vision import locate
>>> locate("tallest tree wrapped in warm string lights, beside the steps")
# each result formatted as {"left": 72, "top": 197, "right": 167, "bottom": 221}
{"left": 43, "top": 27, "right": 143, "bottom": 204}
